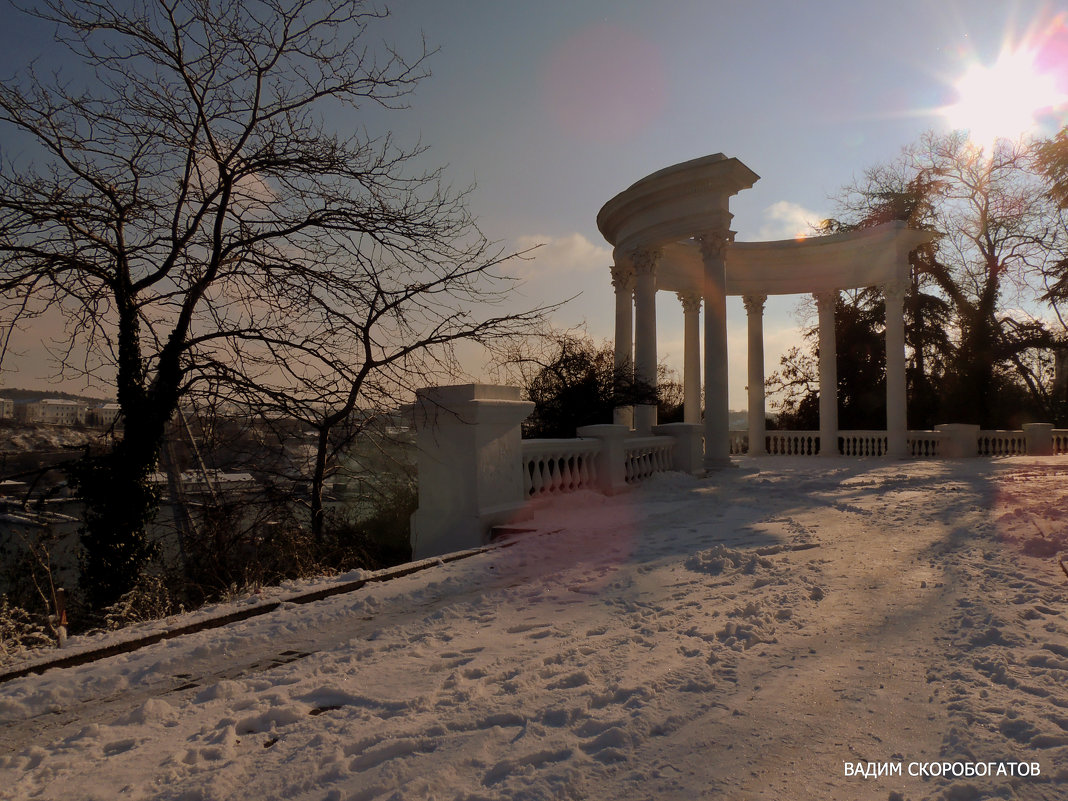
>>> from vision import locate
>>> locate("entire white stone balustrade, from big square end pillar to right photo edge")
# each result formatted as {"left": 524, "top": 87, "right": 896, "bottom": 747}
{"left": 411, "top": 384, "right": 1068, "bottom": 559}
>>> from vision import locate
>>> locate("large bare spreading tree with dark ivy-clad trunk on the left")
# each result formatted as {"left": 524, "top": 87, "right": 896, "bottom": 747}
{"left": 0, "top": 0, "right": 546, "bottom": 604}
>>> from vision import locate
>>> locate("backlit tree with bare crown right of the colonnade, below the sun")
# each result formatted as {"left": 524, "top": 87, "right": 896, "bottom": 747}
{"left": 820, "top": 132, "right": 1068, "bottom": 426}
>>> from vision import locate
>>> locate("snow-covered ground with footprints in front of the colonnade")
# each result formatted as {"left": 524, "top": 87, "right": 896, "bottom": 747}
{"left": 0, "top": 457, "right": 1068, "bottom": 801}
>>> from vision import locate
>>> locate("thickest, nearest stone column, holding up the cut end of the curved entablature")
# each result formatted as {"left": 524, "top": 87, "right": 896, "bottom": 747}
{"left": 698, "top": 230, "right": 733, "bottom": 470}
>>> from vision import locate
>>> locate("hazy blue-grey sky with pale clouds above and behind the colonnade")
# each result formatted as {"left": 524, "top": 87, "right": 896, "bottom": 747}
{"left": 0, "top": 0, "right": 1068, "bottom": 408}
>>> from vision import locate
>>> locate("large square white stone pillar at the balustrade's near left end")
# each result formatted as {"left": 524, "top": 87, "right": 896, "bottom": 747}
{"left": 411, "top": 383, "right": 534, "bottom": 560}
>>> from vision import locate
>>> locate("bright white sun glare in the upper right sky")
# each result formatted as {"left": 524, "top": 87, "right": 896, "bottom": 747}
{"left": 942, "top": 21, "right": 1068, "bottom": 147}
